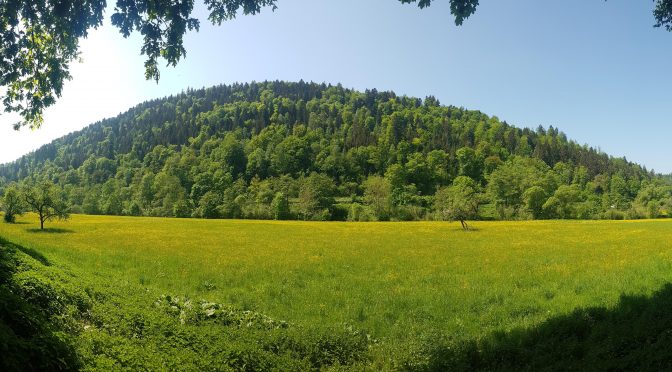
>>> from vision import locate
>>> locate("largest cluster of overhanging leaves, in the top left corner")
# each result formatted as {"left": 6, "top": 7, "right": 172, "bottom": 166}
{"left": 0, "top": 0, "right": 105, "bottom": 127}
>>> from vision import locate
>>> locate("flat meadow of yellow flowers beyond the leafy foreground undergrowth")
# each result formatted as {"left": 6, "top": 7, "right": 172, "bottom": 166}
{"left": 0, "top": 215, "right": 672, "bottom": 370}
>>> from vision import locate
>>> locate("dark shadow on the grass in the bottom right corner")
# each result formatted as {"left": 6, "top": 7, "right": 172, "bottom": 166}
{"left": 426, "top": 284, "right": 672, "bottom": 371}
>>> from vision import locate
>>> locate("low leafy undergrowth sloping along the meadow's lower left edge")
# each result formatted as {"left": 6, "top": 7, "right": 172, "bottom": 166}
{"left": 0, "top": 234, "right": 375, "bottom": 371}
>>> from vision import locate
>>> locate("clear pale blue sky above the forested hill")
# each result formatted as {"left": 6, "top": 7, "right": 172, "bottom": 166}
{"left": 0, "top": 0, "right": 672, "bottom": 173}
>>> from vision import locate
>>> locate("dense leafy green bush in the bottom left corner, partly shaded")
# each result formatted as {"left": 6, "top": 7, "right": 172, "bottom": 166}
{"left": 0, "top": 240, "right": 91, "bottom": 371}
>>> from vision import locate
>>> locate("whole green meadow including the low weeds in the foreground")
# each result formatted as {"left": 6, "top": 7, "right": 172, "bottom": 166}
{"left": 0, "top": 215, "right": 672, "bottom": 370}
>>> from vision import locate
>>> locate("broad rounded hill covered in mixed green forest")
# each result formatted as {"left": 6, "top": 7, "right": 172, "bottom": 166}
{"left": 0, "top": 82, "right": 672, "bottom": 220}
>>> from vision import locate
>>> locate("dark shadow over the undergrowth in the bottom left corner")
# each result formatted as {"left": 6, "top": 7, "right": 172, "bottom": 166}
{"left": 0, "top": 240, "right": 80, "bottom": 371}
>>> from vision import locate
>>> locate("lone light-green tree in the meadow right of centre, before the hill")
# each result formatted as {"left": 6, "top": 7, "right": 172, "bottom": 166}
{"left": 434, "top": 176, "right": 480, "bottom": 230}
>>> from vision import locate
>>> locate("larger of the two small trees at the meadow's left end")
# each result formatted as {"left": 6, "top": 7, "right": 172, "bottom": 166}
{"left": 23, "top": 181, "right": 70, "bottom": 230}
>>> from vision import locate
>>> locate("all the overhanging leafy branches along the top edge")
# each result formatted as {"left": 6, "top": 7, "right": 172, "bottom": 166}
{"left": 5, "top": 0, "right": 672, "bottom": 129}
